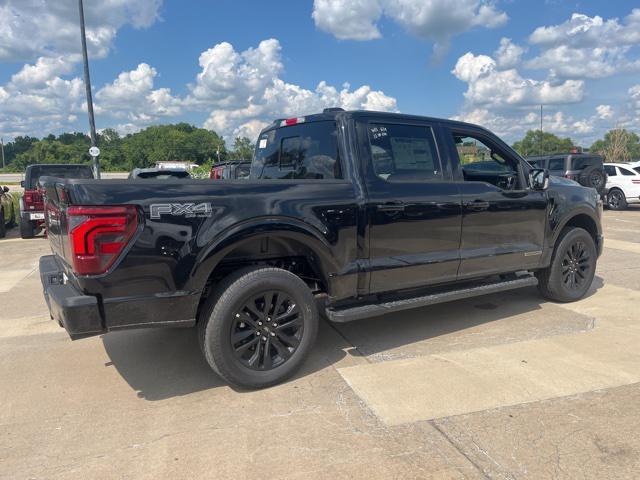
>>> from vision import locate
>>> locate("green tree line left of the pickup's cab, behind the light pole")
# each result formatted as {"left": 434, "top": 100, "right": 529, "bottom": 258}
{"left": 0, "top": 123, "right": 254, "bottom": 172}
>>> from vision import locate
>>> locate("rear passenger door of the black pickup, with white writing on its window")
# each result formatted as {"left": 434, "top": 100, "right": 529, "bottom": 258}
{"left": 357, "top": 116, "right": 461, "bottom": 293}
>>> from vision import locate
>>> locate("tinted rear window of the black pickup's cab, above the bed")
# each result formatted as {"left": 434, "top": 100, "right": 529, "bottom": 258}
{"left": 250, "top": 121, "right": 342, "bottom": 180}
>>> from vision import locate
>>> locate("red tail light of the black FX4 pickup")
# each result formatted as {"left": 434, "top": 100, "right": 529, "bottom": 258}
{"left": 67, "top": 205, "right": 138, "bottom": 275}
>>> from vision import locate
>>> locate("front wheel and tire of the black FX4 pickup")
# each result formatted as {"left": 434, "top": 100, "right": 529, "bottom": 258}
{"left": 536, "top": 227, "right": 598, "bottom": 302}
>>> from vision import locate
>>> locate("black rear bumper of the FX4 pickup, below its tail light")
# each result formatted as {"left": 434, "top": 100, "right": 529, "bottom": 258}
{"left": 40, "top": 255, "right": 105, "bottom": 340}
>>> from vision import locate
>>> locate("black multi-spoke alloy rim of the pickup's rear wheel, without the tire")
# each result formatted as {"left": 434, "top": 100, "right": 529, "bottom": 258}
{"left": 230, "top": 290, "right": 304, "bottom": 370}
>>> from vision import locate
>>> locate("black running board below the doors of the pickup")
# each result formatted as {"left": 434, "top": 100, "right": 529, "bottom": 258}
{"left": 325, "top": 275, "right": 538, "bottom": 323}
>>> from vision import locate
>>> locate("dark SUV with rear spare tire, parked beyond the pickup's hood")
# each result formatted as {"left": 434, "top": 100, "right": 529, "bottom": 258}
{"left": 527, "top": 153, "right": 607, "bottom": 196}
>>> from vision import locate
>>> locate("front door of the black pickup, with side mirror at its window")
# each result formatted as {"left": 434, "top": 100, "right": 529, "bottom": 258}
{"left": 444, "top": 126, "right": 548, "bottom": 279}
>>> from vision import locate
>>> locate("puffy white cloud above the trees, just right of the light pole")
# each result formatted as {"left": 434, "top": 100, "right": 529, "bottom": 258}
{"left": 95, "top": 63, "right": 182, "bottom": 124}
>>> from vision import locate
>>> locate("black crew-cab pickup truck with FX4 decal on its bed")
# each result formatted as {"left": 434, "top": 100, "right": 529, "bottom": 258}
{"left": 40, "top": 109, "right": 603, "bottom": 388}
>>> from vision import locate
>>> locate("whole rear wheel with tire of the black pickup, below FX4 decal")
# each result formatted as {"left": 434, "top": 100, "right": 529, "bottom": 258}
{"left": 198, "top": 267, "right": 318, "bottom": 388}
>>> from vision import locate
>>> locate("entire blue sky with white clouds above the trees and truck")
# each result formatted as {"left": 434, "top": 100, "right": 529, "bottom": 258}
{"left": 0, "top": 0, "right": 640, "bottom": 145}
